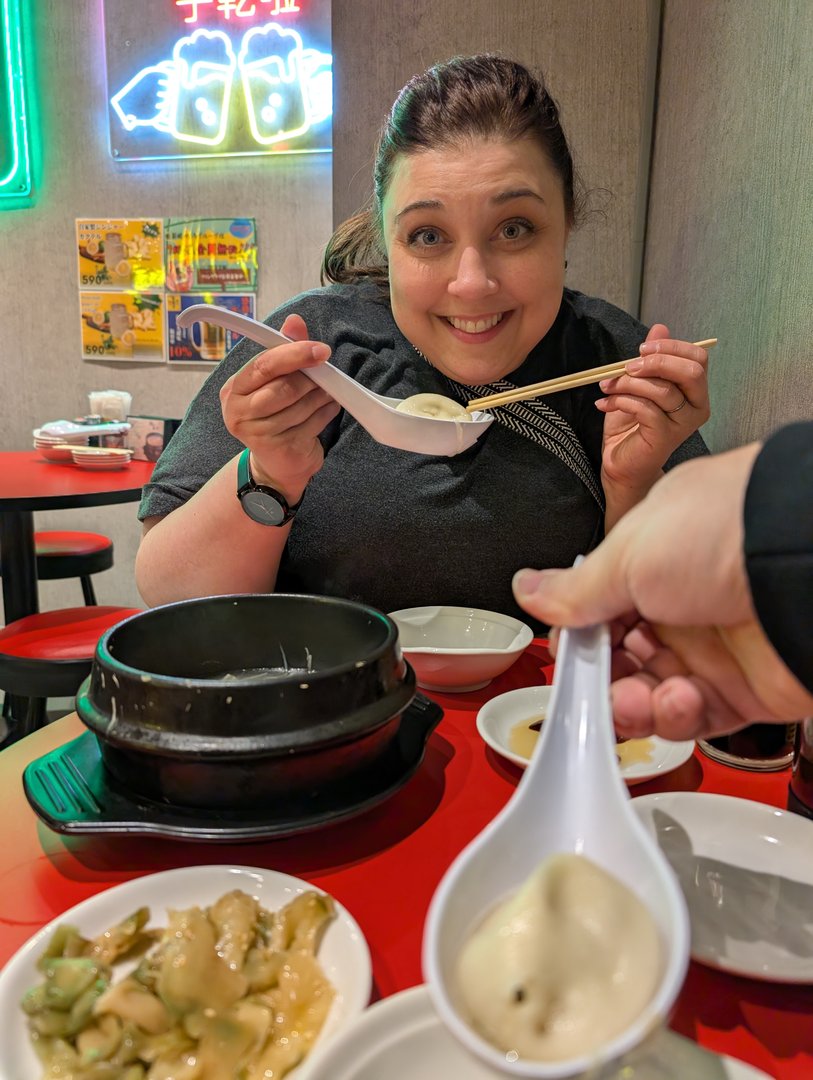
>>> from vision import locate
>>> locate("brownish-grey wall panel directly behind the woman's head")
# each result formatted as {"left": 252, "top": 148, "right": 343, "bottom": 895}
{"left": 334, "top": 0, "right": 659, "bottom": 310}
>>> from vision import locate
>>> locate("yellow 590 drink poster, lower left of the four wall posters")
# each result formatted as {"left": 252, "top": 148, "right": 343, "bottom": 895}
{"left": 79, "top": 293, "right": 166, "bottom": 363}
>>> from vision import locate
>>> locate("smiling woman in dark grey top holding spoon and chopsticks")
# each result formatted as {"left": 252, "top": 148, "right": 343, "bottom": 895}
{"left": 137, "top": 56, "right": 708, "bottom": 630}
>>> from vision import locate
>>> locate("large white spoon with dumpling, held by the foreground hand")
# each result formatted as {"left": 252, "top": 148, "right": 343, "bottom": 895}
{"left": 423, "top": 625, "right": 689, "bottom": 1080}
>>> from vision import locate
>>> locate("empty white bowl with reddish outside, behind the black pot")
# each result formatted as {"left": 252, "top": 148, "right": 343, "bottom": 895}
{"left": 390, "top": 605, "right": 533, "bottom": 693}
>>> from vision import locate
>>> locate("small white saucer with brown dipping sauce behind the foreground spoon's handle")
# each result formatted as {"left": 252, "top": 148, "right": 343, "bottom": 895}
{"left": 477, "top": 686, "right": 694, "bottom": 784}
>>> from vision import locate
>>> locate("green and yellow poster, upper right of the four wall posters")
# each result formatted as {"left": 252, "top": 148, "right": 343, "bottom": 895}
{"left": 165, "top": 217, "right": 257, "bottom": 293}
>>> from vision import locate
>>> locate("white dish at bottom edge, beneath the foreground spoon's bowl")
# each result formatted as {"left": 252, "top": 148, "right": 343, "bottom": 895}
{"left": 300, "top": 986, "right": 770, "bottom": 1080}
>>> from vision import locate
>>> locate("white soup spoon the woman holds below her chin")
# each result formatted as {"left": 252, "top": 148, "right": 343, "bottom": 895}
{"left": 176, "top": 303, "right": 493, "bottom": 458}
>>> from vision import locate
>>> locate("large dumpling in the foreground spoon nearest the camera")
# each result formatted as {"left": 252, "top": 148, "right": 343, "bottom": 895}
{"left": 457, "top": 854, "right": 662, "bottom": 1062}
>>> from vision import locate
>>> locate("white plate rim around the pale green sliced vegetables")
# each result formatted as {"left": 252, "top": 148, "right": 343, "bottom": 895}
{"left": 0, "top": 866, "right": 372, "bottom": 1080}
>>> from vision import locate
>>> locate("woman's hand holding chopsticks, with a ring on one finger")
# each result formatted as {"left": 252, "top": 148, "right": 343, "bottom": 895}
{"left": 596, "top": 323, "right": 710, "bottom": 492}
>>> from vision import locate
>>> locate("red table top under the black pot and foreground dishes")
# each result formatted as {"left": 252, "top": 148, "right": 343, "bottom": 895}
{"left": 0, "top": 643, "right": 813, "bottom": 1080}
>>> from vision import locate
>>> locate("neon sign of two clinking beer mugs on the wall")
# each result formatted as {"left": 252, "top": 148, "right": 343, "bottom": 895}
{"left": 105, "top": 0, "right": 333, "bottom": 160}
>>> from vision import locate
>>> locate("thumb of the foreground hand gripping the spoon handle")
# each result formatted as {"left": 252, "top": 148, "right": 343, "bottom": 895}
{"left": 513, "top": 534, "right": 635, "bottom": 626}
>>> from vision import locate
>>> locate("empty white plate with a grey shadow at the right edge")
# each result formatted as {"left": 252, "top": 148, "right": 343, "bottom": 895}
{"left": 633, "top": 792, "right": 813, "bottom": 983}
